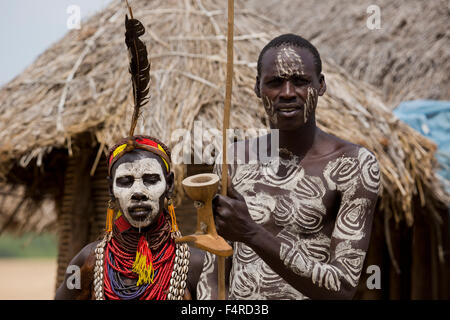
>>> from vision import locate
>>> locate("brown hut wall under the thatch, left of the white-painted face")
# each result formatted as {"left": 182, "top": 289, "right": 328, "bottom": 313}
{"left": 56, "top": 144, "right": 109, "bottom": 287}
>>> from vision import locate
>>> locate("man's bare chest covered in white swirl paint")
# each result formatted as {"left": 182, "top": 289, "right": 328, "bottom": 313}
{"left": 233, "top": 161, "right": 339, "bottom": 235}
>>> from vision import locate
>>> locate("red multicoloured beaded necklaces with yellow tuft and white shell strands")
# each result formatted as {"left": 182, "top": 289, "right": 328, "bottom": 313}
{"left": 94, "top": 210, "right": 190, "bottom": 300}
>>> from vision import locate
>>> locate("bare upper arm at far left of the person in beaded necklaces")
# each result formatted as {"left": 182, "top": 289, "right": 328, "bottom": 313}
{"left": 55, "top": 241, "right": 99, "bottom": 300}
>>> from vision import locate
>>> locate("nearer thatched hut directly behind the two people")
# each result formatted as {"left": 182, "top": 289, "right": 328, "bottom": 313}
{"left": 0, "top": 0, "right": 448, "bottom": 297}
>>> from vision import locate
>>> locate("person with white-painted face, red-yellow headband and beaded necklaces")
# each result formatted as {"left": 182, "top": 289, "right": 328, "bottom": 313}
{"left": 56, "top": 136, "right": 202, "bottom": 300}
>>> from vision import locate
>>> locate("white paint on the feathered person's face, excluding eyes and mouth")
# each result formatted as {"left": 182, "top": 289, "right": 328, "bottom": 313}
{"left": 113, "top": 158, "right": 166, "bottom": 228}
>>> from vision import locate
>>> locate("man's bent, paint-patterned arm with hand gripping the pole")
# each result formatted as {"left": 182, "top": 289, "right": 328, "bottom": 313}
{"left": 214, "top": 148, "right": 379, "bottom": 299}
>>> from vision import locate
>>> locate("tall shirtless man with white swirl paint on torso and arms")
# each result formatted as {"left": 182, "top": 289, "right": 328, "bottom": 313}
{"left": 197, "top": 34, "right": 380, "bottom": 300}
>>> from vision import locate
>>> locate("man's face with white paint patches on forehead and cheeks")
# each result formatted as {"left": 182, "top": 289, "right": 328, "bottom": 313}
{"left": 257, "top": 45, "right": 325, "bottom": 130}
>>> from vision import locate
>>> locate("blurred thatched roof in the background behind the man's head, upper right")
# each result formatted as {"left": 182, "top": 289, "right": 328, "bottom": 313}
{"left": 249, "top": 0, "right": 450, "bottom": 109}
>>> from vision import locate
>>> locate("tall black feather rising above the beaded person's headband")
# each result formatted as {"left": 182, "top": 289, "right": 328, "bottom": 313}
{"left": 125, "top": 15, "right": 150, "bottom": 137}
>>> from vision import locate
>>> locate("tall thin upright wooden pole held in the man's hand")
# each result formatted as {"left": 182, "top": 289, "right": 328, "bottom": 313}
{"left": 217, "top": 0, "right": 234, "bottom": 300}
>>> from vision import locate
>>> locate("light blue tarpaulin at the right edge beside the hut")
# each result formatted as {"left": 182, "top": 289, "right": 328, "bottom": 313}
{"left": 394, "top": 100, "right": 450, "bottom": 193}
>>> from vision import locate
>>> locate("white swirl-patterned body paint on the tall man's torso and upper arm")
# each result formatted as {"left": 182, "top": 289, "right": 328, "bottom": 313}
{"left": 197, "top": 144, "right": 380, "bottom": 300}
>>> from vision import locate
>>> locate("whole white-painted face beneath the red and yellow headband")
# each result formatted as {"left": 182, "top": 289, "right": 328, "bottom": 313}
{"left": 113, "top": 158, "right": 166, "bottom": 228}
